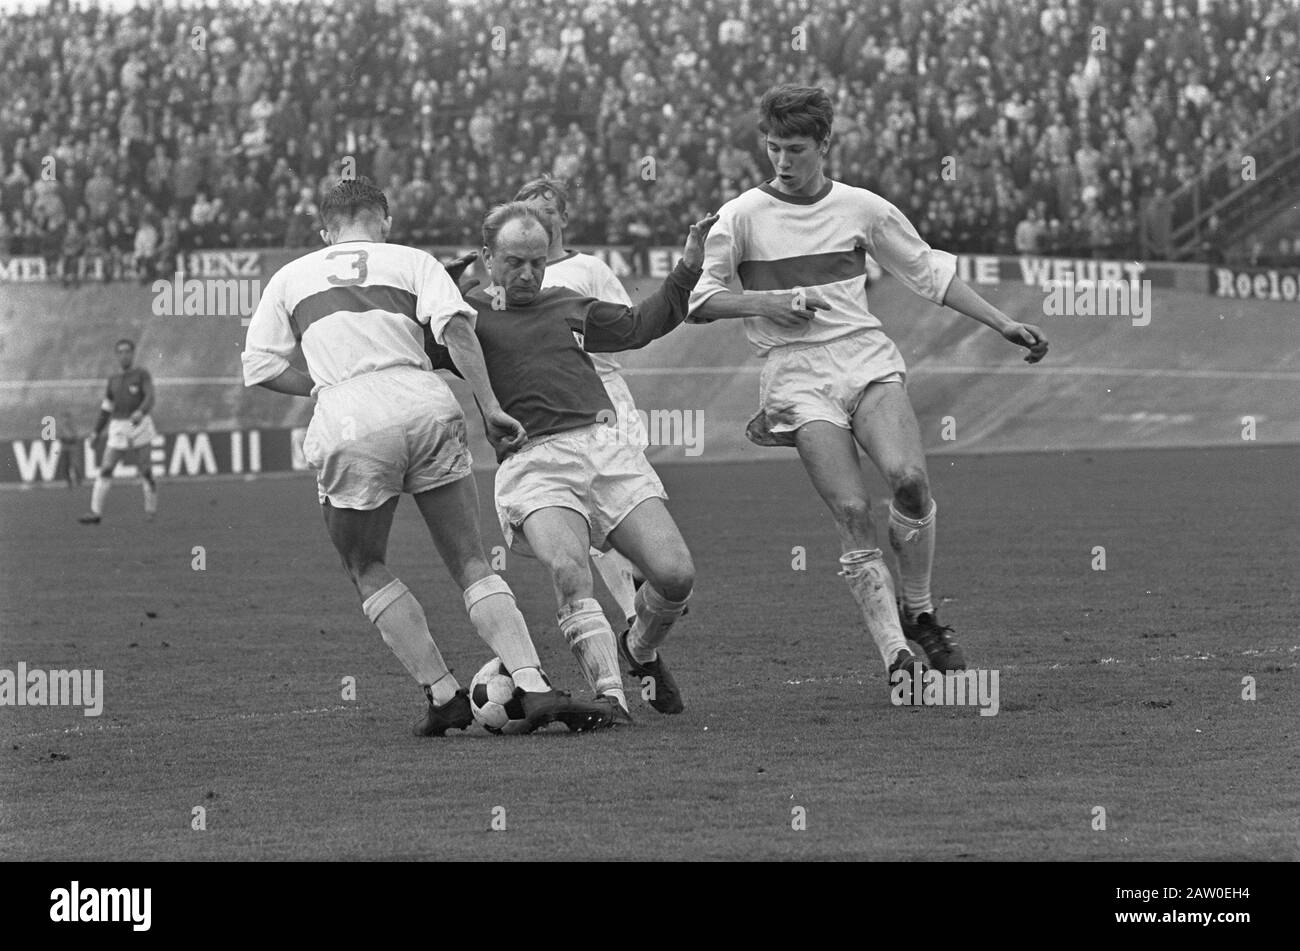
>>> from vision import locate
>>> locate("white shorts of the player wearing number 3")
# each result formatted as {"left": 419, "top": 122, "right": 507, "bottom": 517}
{"left": 303, "top": 366, "right": 472, "bottom": 511}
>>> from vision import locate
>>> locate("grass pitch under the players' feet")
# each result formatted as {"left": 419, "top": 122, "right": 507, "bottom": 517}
{"left": 0, "top": 447, "right": 1300, "bottom": 860}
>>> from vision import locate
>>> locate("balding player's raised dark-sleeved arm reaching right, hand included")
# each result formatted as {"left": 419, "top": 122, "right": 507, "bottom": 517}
{"left": 582, "top": 214, "right": 718, "bottom": 353}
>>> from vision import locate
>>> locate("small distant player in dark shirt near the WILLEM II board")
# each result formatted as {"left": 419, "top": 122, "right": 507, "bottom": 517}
{"left": 77, "top": 340, "right": 159, "bottom": 525}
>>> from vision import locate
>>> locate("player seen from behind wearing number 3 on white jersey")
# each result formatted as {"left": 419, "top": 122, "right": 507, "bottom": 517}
{"left": 243, "top": 179, "right": 612, "bottom": 737}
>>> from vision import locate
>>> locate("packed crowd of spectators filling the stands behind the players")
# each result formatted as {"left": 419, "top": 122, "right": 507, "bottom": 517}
{"left": 0, "top": 0, "right": 1300, "bottom": 281}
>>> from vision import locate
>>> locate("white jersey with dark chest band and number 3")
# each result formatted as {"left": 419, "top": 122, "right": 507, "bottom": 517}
{"left": 243, "top": 240, "right": 475, "bottom": 394}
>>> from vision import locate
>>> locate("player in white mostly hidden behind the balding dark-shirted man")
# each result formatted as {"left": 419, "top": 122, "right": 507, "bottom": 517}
{"left": 515, "top": 178, "right": 644, "bottom": 628}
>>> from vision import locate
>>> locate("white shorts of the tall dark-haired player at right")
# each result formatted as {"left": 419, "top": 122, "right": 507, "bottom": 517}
{"left": 759, "top": 329, "right": 907, "bottom": 433}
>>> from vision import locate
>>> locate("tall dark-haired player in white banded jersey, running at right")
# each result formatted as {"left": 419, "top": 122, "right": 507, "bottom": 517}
{"left": 690, "top": 84, "right": 1048, "bottom": 682}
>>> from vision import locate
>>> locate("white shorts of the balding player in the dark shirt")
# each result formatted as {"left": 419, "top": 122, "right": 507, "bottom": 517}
{"left": 495, "top": 424, "right": 668, "bottom": 555}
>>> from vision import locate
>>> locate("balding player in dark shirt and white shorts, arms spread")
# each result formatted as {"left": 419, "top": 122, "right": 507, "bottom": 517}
{"left": 430, "top": 201, "right": 716, "bottom": 722}
